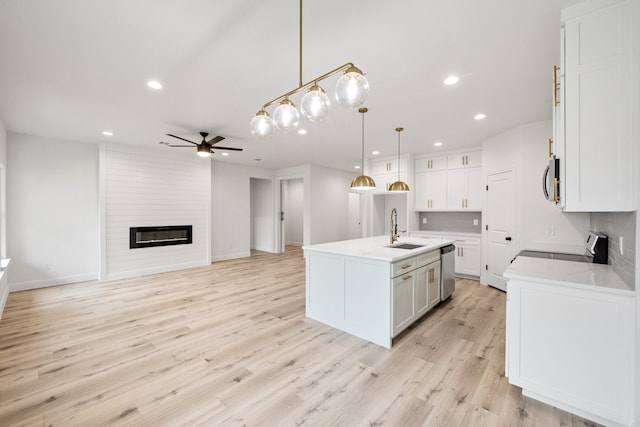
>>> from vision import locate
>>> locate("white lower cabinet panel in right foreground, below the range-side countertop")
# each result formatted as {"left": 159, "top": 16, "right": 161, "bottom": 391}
{"left": 505, "top": 279, "right": 635, "bottom": 425}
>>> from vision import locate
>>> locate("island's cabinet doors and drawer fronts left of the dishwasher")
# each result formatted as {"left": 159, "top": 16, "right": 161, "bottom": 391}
{"left": 391, "top": 250, "right": 440, "bottom": 336}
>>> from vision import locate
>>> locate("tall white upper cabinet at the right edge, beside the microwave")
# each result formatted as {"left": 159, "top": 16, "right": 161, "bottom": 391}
{"left": 556, "top": 0, "right": 639, "bottom": 212}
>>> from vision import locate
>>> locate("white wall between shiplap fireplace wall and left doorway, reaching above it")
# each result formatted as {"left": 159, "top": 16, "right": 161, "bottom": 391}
{"left": 211, "top": 160, "right": 273, "bottom": 261}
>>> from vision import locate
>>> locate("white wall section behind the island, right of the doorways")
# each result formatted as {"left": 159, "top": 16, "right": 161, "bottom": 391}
{"left": 305, "top": 166, "right": 353, "bottom": 244}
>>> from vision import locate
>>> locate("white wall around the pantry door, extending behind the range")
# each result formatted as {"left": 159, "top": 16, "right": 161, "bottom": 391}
{"left": 481, "top": 121, "right": 590, "bottom": 283}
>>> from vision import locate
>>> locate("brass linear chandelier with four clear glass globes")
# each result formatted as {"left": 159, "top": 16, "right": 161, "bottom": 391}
{"left": 250, "top": 0, "right": 369, "bottom": 139}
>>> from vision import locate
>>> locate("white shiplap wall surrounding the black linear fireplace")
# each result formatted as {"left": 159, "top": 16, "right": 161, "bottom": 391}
{"left": 100, "top": 145, "right": 211, "bottom": 280}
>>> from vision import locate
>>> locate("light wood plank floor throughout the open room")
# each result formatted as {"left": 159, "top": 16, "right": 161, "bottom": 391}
{"left": 0, "top": 247, "right": 593, "bottom": 427}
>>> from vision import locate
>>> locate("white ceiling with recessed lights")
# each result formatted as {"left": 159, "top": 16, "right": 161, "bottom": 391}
{"left": 0, "top": 0, "right": 579, "bottom": 171}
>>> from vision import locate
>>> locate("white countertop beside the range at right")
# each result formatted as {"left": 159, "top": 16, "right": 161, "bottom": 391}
{"left": 503, "top": 256, "right": 635, "bottom": 296}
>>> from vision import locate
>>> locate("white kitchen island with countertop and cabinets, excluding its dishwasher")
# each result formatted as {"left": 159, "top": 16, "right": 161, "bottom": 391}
{"left": 303, "top": 236, "right": 453, "bottom": 348}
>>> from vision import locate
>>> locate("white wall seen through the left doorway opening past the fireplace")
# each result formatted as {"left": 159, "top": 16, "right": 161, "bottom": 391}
{"left": 250, "top": 178, "right": 274, "bottom": 252}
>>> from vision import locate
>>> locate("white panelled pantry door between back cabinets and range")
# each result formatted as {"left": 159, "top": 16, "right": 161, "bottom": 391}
{"left": 485, "top": 171, "right": 516, "bottom": 291}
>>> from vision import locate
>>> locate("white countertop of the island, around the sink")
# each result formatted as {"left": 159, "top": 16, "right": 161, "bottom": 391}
{"left": 302, "top": 236, "right": 454, "bottom": 262}
